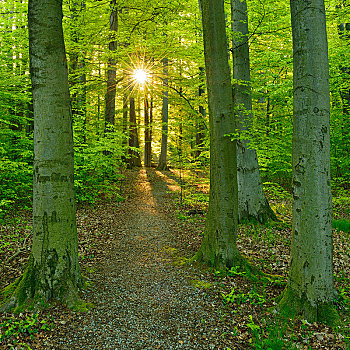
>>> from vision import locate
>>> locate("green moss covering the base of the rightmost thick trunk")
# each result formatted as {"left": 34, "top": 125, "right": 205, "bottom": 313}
{"left": 275, "top": 287, "right": 340, "bottom": 326}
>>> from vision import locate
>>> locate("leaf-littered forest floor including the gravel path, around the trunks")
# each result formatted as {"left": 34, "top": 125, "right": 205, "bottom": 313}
{"left": 0, "top": 169, "right": 350, "bottom": 350}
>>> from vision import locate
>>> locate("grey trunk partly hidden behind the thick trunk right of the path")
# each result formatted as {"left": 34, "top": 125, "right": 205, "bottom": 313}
{"left": 231, "top": 0, "right": 277, "bottom": 223}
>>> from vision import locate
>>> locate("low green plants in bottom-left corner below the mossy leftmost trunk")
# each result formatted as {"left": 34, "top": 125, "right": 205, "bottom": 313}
{"left": 0, "top": 313, "right": 53, "bottom": 344}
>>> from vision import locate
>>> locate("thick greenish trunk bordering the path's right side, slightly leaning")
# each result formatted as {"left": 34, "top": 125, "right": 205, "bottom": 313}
{"left": 195, "top": 0, "right": 239, "bottom": 269}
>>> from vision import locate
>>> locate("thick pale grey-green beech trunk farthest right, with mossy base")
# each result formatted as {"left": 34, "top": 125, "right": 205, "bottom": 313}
{"left": 279, "top": 0, "right": 338, "bottom": 324}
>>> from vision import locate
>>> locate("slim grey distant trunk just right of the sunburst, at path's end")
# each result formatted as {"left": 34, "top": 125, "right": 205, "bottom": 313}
{"left": 157, "top": 58, "right": 169, "bottom": 170}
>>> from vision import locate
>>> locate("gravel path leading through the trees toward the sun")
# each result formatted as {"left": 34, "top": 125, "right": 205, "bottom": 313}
{"left": 51, "top": 169, "right": 237, "bottom": 350}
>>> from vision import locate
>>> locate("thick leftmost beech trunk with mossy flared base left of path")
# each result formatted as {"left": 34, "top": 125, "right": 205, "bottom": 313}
{"left": 2, "top": 0, "right": 83, "bottom": 311}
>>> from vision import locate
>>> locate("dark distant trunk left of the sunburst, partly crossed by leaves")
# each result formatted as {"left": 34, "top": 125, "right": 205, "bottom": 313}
{"left": 105, "top": 0, "right": 118, "bottom": 130}
